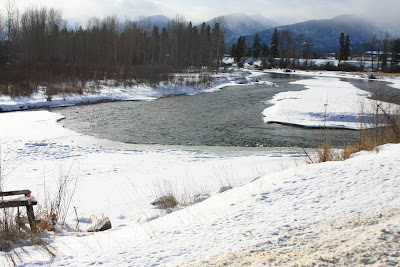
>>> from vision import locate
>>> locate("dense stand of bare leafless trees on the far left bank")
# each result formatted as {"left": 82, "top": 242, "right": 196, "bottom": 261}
{"left": 0, "top": 4, "right": 224, "bottom": 96}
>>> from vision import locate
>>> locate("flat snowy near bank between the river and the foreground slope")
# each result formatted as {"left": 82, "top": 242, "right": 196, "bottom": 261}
{"left": 0, "top": 111, "right": 303, "bottom": 265}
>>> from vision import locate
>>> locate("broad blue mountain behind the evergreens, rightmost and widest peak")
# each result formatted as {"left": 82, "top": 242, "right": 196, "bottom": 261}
{"left": 246, "top": 15, "right": 383, "bottom": 52}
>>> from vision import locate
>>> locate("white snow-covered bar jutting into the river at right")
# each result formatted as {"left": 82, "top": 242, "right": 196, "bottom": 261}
{"left": 263, "top": 77, "right": 399, "bottom": 129}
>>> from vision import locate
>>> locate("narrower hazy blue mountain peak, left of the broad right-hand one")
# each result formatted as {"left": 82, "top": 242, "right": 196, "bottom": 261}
{"left": 206, "top": 13, "right": 276, "bottom": 44}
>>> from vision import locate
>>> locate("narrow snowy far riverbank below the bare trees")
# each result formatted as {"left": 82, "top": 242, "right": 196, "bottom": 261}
{"left": 0, "top": 69, "right": 400, "bottom": 112}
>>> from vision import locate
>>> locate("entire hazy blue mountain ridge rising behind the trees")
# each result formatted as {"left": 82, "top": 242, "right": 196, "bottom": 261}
{"left": 141, "top": 13, "right": 400, "bottom": 52}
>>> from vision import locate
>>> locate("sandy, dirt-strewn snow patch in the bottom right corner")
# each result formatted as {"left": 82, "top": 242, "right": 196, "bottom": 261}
{"left": 190, "top": 209, "right": 400, "bottom": 266}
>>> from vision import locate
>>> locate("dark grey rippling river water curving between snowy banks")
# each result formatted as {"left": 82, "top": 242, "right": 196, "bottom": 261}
{"left": 55, "top": 74, "right": 394, "bottom": 148}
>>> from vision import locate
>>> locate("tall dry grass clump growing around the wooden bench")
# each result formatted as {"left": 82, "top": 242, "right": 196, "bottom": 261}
{"left": 0, "top": 165, "right": 78, "bottom": 266}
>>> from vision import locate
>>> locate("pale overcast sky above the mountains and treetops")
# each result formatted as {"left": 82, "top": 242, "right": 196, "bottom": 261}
{"left": 13, "top": 0, "right": 400, "bottom": 25}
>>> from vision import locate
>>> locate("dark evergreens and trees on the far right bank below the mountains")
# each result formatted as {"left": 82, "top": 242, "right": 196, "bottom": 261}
{"left": 230, "top": 29, "right": 400, "bottom": 72}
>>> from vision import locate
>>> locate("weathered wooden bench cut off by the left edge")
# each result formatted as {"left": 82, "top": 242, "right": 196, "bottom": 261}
{"left": 0, "top": 190, "right": 37, "bottom": 232}
